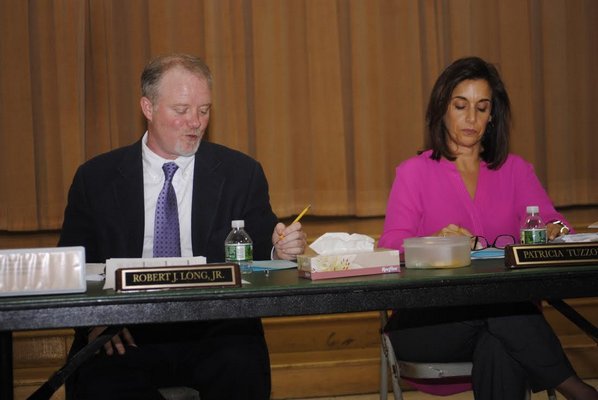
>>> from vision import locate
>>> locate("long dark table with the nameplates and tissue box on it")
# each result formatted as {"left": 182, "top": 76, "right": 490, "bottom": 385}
{"left": 0, "top": 259, "right": 598, "bottom": 399}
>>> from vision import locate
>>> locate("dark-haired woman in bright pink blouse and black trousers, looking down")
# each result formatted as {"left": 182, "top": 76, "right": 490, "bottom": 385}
{"left": 379, "top": 57, "right": 598, "bottom": 399}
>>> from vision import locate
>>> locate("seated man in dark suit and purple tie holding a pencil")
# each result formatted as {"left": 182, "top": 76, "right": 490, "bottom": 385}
{"left": 59, "top": 55, "right": 306, "bottom": 400}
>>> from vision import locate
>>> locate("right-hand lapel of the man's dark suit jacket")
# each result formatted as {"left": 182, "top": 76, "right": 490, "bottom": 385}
{"left": 191, "top": 142, "right": 225, "bottom": 255}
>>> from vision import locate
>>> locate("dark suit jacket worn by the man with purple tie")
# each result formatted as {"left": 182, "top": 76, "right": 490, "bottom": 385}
{"left": 59, "top": 141, "right": 277, "bottom": 345}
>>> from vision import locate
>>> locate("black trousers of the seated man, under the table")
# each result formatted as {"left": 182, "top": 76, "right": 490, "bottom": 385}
{"left": 66, "top": 319, "right": 271, "bottom": 400}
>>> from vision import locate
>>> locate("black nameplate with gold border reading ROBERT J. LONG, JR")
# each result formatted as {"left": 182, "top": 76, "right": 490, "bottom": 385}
{"left": 116, "top": 263, "right": 242, "bottom": 291}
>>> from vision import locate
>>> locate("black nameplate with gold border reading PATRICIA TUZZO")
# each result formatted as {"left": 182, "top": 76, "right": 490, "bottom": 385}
{"left": 505, "top": 242, "right": 598, "bottom": 268}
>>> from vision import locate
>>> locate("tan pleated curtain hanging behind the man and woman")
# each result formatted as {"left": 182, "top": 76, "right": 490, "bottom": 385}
{"left": 0, "top": 0, "right": 598, "bottom": 231}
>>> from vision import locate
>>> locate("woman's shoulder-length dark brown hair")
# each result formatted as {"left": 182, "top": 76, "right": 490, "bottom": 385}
{"left": 426, "top": 57, "right": 511, "bottom": 169}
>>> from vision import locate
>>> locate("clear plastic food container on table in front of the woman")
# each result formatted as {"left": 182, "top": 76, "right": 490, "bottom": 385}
{"left": 403, "top": 236, "right": 471, "bottom": 268}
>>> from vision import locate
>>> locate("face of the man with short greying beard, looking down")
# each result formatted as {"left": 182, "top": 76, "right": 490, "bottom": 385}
{"left": 141, "top": 67, "right": 212, "bottom": 160}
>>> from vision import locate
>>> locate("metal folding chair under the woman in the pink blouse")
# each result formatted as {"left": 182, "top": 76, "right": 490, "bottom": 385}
{"left": 380, "top": 311, "right": 557, "bottom": 400}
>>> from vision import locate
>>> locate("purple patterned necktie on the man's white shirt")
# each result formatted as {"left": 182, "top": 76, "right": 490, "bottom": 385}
{"left": 154, "top": 162, "right": 181, "bottom": 257}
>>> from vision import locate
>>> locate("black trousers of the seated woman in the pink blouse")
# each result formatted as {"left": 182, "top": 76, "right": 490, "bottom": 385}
{"left": 385, "top": 303, "right": 575, "bottom": 400}
